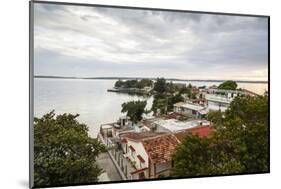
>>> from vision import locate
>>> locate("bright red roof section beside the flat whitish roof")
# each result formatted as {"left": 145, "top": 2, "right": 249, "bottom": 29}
{"left": 175, "top": 125, "right": 212, "bottom": 141}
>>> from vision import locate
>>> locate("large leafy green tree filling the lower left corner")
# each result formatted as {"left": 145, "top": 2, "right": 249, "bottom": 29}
{"left": 34, "top": 111, "right": 106, "bottom": 187}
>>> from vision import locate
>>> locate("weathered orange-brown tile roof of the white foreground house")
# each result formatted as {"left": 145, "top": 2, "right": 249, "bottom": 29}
{"left": 142, "top": 134, "right": 178, "bottom": 163}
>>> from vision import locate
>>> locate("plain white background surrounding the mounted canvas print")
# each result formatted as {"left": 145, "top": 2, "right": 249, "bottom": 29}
{"left": 0, "top": 0, "right": 281, "bottom": 189}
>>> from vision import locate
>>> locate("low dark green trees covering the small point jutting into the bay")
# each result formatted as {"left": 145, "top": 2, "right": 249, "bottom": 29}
{"left": 114, "top": 79, "right": 153, "bottom": 89}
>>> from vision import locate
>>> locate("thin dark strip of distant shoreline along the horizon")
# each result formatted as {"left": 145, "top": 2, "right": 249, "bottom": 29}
{"left": 34, "top": 75, "right": 268, "bottom": 84}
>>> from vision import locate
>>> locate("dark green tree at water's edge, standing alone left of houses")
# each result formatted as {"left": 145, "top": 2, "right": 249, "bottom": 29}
{"left": 121, "top": 100, "right": 146, "bottom": 123}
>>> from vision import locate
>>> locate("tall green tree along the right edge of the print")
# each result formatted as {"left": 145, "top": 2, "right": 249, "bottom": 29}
{"left": 220, "top": 96, "right": 269, "bottom": 173}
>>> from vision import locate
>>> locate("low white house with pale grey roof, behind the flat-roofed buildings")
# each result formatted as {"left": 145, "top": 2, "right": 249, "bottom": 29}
{"left": 174, "top": 102, "right": 207, "bottom": 118}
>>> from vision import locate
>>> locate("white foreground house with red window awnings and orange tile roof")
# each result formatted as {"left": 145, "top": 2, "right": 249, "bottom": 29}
{"left": 121, "top": 132, "right": 178, "bottom": 179}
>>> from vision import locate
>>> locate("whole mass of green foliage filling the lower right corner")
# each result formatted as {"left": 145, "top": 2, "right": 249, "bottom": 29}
{"left": 171, "top": 96, "right": 269, "bottom": 177}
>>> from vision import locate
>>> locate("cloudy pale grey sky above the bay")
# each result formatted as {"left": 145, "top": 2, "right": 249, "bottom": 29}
{"left": 34, "top": 3, "right": 268, "bottom": 81}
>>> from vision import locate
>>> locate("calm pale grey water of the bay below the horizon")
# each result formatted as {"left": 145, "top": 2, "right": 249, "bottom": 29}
{"left": 34, "top": 78, "right": 267, "bottom": 137}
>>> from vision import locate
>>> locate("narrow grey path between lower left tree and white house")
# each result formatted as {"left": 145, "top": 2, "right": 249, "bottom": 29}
{"left": 97, "top": 153, "right": 122, "bottom": 181}
